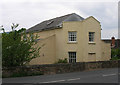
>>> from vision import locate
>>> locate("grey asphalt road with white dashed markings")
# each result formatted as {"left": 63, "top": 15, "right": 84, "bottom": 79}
{"left": 2, "top": 68, "right": 120, "bottom": 83}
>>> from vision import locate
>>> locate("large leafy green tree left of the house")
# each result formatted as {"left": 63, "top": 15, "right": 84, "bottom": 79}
{"left": 2, "top": 24, "right": 41, "bottom": 67}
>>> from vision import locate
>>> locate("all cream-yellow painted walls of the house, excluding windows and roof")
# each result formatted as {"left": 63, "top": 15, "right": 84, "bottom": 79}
{"left": 30, "top": 17, "right": 111, "bottom": 65}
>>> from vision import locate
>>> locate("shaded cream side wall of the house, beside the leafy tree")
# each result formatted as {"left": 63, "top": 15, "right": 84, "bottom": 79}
{"left": 29, "top": 30, "right": 56, "bottom": 65}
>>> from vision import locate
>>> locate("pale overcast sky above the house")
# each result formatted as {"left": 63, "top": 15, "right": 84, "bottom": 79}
{"left": 0, "top": 0, "right": 118, "bottom": 39}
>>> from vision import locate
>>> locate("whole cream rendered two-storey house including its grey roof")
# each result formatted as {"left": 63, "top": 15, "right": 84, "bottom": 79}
{"left": 27, "top": 13, "right": 111, "bottom": 65}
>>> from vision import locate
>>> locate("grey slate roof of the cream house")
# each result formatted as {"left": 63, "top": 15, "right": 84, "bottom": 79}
{"left": 27, "top": 13, "right": 84, "bottom": 32}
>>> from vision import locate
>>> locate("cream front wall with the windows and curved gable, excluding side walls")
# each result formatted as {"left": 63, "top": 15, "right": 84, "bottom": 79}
{"left": 56, "top": 17, "right": 101, "bottom": 62}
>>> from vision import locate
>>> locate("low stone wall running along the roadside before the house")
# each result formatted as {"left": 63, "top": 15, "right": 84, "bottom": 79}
{"left": 2, "top": 60, "right": 118, "bottom": 77}
